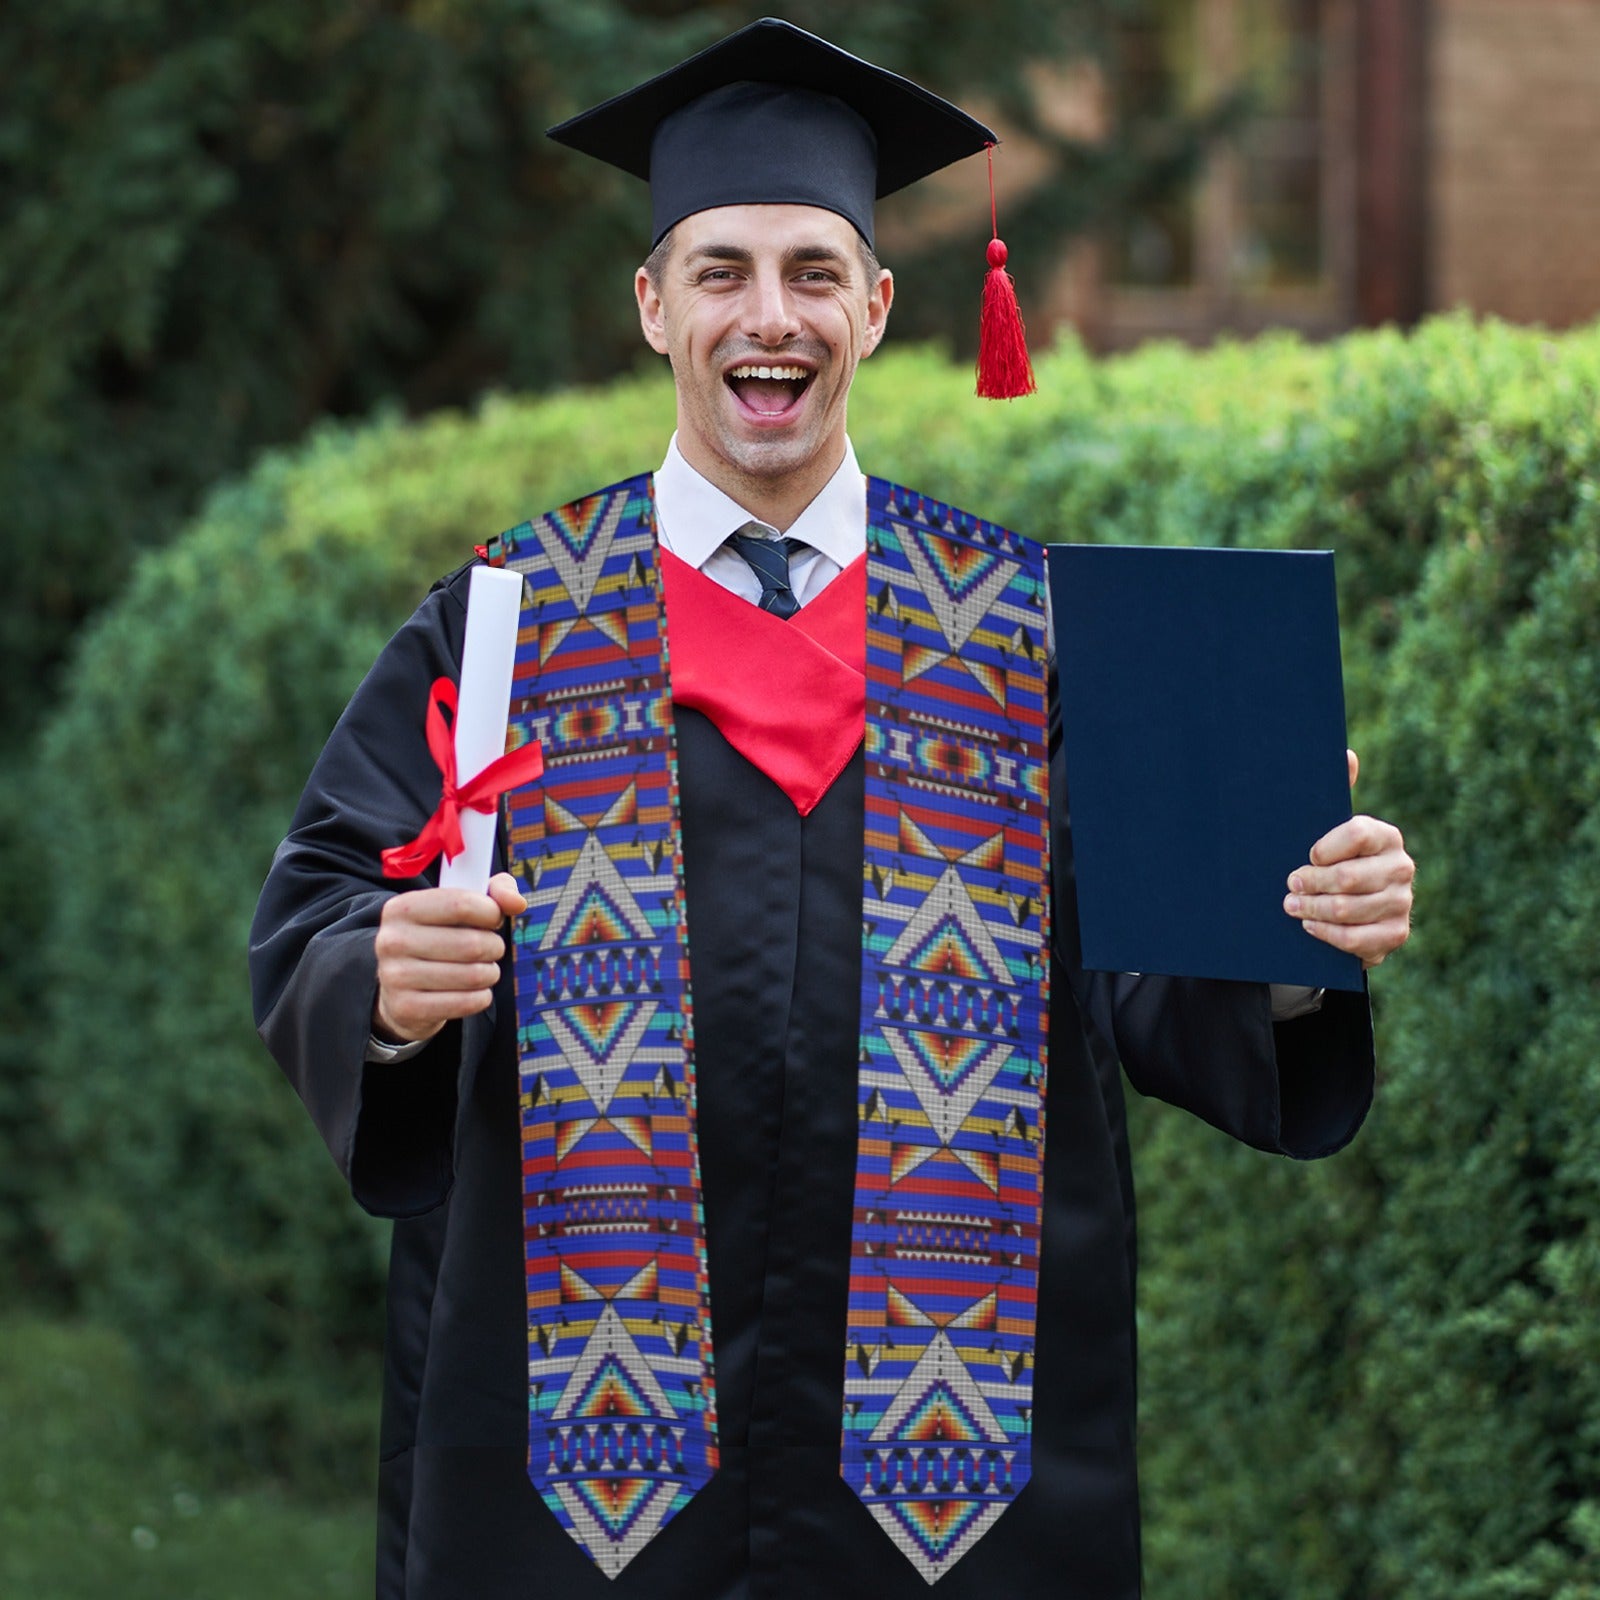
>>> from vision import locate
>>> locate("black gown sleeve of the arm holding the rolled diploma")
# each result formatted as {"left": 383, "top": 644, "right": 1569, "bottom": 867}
{"left": 250, "top": 568, "right": 493, "bottom": 1216}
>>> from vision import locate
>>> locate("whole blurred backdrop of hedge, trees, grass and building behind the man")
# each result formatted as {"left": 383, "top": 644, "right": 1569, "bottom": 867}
{"left": 0, "top": 0, "right": 1600, "bottom": 1600}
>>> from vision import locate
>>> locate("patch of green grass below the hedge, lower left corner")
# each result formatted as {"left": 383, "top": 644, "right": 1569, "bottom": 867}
{"left": 0, "top": 1317, "right": 373, "bottom": 1600}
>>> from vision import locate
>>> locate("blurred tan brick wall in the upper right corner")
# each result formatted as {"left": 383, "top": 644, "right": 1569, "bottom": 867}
{"left": 1429, "top": 0, "right": 1600, "bottom": 326}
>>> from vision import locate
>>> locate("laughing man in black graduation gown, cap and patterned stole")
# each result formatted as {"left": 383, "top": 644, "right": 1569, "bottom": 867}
{"left": 253, "top": 22, "right": 1411, "bottom": 1600}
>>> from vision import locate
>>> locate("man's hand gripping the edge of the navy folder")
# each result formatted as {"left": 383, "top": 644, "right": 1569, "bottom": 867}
{"left": 1283, "top": 750, "right": 1416, "bottom": 966}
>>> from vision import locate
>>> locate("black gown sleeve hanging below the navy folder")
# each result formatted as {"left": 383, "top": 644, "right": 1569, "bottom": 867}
{"left": 1050, "top": 678, "right": 1374, "bottom": 1158}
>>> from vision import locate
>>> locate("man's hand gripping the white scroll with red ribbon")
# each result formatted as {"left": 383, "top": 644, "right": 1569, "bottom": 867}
{"left": 373, "top": 872, "right": 528, "bottom": 1043}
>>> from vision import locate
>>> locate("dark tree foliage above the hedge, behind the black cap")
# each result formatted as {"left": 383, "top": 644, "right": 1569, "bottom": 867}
{"left": 0, "top": 0, "right": 1192, "bottom": 742}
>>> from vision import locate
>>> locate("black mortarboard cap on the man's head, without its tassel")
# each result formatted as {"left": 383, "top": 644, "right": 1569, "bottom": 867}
{"left": 550, "top": 18, "right": 997, "bottom": 245}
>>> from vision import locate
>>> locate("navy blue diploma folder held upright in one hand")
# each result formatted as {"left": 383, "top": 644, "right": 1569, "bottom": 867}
{"left": 1048, "top": 544, "right": 1362, "bottom": 989}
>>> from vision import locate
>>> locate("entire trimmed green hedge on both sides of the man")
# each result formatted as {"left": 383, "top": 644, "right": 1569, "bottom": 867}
{"left": 31, "top": 320, "right": 1600, "bottom": 1600}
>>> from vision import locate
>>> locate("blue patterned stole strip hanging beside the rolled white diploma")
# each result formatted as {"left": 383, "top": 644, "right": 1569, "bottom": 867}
{"left": 490, "top": 475, "right": 717, "bottom": 1578}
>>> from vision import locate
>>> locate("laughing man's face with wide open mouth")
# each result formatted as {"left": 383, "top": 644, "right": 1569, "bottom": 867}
{"left": 635, "top": 205, "right": 894, "bottom": 493}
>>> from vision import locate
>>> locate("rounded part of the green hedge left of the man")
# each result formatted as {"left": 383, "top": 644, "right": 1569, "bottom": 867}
{"left": 43, "top": 371, "right": 664, "bottom": 1477}
